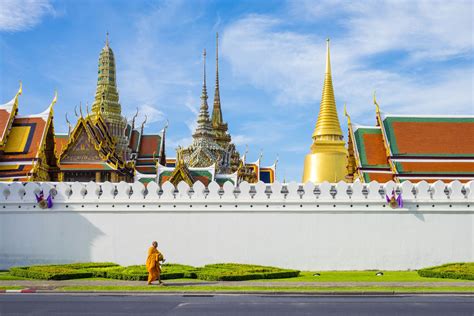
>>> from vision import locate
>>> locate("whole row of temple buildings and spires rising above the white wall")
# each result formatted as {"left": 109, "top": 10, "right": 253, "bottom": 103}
{"left": 0, "top": 37, "right": 474, "bottom": 185}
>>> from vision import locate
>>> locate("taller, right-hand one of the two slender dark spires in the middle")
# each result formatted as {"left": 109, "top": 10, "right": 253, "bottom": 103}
{"left": 212, "top": 33, "right": 231, "bottom": 148}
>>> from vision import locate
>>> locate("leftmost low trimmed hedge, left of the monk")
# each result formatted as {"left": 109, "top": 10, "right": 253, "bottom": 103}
{"left": 10, "top": 262, "right": 117, "bottom": 280}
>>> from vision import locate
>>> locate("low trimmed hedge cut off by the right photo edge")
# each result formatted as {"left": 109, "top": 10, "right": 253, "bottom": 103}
{"left": 417, "top": 262, "right": 474, "bottom": 280}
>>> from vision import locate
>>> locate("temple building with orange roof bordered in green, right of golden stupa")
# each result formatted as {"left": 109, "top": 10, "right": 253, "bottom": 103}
{"left": 346, "top": 95, "right": 474, "bottom": 182}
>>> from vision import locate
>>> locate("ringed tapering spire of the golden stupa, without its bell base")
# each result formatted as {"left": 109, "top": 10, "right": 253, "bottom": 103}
{"left": 313, "top": 39, "right": 343, "bottom": 140}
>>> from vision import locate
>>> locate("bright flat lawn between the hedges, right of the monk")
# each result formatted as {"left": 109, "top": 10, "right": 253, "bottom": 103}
{"left": 248, "top": 271, "right": 474, "bottom": 285}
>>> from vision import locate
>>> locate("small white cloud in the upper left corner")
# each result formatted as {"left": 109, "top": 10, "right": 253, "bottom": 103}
{"left": 0, "top": 0, "right": 54, "bottom": 32}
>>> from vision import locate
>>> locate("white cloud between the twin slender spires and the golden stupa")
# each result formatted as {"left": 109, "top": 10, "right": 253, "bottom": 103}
{"left": 221, "top": 15, "right": 319, "bottom": 104}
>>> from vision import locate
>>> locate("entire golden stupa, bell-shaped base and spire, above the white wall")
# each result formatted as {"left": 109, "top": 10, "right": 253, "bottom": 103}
{"left": 303, "top": 39, "right": 347, "bottom": 183}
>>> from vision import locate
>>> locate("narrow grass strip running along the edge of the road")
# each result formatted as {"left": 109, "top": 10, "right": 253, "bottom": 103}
{"left": 57, "top": 285, "right": 474, "bottom": 293}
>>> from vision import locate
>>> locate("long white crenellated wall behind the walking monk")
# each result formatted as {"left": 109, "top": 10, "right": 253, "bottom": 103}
{"left": 0, "top": 181, "right": 474, "bottom": 270}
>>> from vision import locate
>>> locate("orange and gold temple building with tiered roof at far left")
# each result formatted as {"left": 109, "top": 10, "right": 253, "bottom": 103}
{"left": 0, "top": 83, "right": 59, "bottom": 181}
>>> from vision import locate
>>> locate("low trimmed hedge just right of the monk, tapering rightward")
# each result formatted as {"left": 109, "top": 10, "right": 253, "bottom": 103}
{"left": 197, "top": 263, "right": 300, "bottom": 281}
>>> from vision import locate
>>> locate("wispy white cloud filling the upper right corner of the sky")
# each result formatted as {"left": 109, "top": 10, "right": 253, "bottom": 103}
{"left": 289, "top": 0, "right": 474, "bottom": 60}
